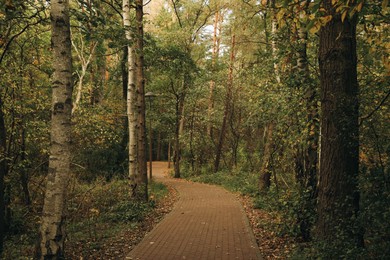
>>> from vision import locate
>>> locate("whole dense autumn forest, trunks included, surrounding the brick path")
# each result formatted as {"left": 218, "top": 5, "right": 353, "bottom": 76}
{"left": 0, "top": 0, "right": 390, "bottom": 259}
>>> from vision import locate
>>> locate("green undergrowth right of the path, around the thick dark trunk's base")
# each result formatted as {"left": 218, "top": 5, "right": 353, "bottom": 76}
{"left": 183, "top": 166, "right": 390, "bottom": 259}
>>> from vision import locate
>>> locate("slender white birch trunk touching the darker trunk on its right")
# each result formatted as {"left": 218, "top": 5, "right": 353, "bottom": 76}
{"left": 122, "top": 0, "right": 142, "bottom": 197}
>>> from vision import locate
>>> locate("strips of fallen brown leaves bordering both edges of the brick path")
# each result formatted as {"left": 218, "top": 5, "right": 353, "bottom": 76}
{"left": 67, "top": 163, "right": 294, "bottom": 259}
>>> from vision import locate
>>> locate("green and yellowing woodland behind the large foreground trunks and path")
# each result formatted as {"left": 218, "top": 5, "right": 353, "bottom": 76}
{"left": 0, "top": 0, "right": 390, "bottom": 259}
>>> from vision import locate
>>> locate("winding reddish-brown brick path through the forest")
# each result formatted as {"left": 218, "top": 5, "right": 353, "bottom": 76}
{"left": 126, "top": 162, "right": 261, "bottom": 260}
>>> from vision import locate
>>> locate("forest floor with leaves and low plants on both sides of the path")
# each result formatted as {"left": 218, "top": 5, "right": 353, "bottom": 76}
{"left": 0, "top": 162, "right": 296, "bottom": 260}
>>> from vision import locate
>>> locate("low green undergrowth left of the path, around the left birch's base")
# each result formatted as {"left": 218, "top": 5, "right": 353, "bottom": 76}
{"left": 0, "top": 176, "right": 168, "bottom": 259}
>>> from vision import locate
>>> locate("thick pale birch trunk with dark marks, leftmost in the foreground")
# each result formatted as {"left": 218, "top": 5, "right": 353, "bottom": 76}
{"left": 37, "top": 0, "right": 73, "bottom": 259}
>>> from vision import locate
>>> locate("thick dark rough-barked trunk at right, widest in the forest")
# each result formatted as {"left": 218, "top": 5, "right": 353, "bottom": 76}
{"left": 317, "top": 0, "right": 362, "bottom": 248}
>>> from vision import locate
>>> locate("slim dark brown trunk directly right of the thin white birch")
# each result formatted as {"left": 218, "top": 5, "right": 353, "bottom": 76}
{"left": 135, "top": 0, "right": 148, "bottom": 201}
